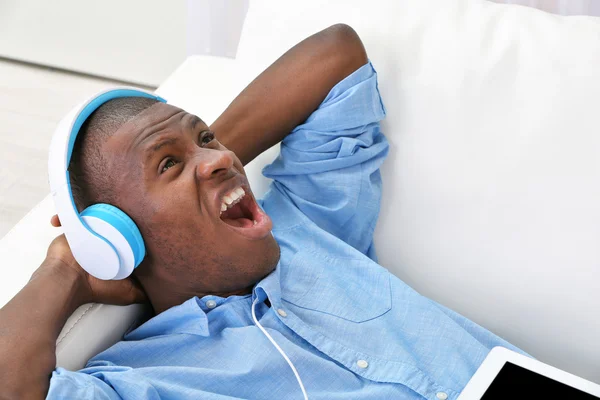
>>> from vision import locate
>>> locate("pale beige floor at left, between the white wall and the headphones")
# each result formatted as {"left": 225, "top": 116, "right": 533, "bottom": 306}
{"left": 0, "top": 60, "right": 154, "bottom": 238}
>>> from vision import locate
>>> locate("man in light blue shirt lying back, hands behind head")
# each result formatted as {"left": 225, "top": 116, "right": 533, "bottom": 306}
{"left": 0, "top": 25, "right": 518, "bottom": 400}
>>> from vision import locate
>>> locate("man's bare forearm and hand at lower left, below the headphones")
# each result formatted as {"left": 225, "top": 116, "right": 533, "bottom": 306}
{"left": 0, "top": 235, "right": 144, "bottom": 399}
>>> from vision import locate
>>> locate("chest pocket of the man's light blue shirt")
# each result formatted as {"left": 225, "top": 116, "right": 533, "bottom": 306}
{"left": 281, "top": 251, "right": 392, "bottom": 322}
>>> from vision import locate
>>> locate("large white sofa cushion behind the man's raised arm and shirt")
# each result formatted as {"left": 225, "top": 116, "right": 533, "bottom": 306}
{"left": 237, "top": 0, "right": 600, "bottom": 382}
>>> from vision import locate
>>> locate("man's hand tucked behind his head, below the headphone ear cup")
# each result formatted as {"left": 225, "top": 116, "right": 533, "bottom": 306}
{"left": 42, "top": 215, "right": 147, "bottom": 305}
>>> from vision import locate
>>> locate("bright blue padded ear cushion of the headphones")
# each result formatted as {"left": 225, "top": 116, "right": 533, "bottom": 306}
{"left": 80, "top": 203, "right": 146, "bottom": 268}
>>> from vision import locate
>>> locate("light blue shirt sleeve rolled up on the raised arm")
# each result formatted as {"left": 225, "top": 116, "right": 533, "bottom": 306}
{"left": 263, "top": 62, "right": 389, "bottom": 254}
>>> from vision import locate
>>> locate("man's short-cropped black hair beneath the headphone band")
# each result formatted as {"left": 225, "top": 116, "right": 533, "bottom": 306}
{"left": 69, "top": 97, "right": 158, "bottom": 212}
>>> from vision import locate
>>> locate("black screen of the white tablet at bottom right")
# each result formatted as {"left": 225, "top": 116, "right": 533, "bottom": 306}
{"left": 481, "top": 361, "right": 598, "bottom": 400}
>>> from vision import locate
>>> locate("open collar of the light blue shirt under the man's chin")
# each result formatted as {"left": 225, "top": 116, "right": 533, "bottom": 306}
{"left": 125, "top": 263, "right": 281, "bottom": 340}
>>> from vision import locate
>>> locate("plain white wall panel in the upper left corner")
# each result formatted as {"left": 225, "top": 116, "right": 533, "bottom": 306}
{"left": 0, "top": 0, "right": 187, "bottom": 86}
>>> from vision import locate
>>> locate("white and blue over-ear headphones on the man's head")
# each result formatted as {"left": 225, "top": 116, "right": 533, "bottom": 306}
{"left": 48, "top": 87, "right": 167, "bottom": 280}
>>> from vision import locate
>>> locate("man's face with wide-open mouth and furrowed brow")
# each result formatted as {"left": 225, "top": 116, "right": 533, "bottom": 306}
{"left": 103, "top": 103, "right": 279, "bottom": 297}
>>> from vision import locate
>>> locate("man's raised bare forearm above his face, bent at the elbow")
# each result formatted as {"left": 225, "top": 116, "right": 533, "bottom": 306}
{"left": 211, "top": 24, "right": 368, "bottom": 165}
